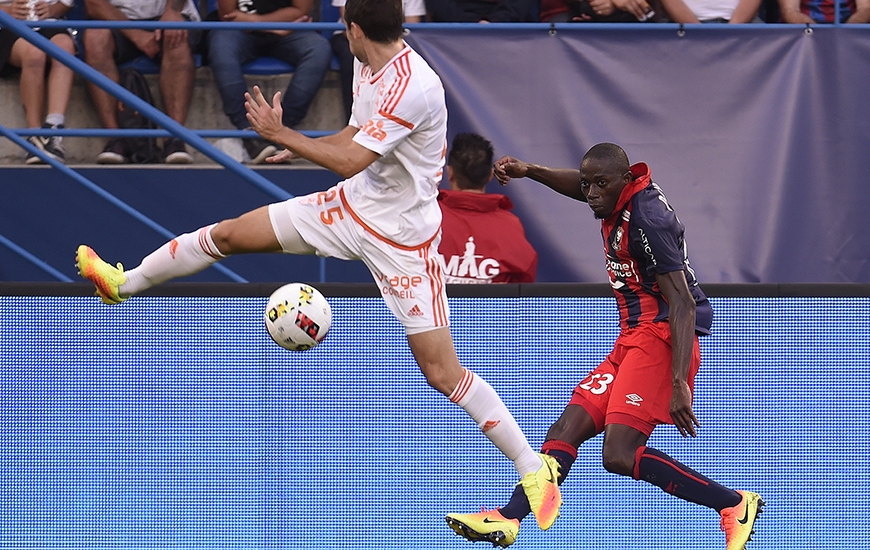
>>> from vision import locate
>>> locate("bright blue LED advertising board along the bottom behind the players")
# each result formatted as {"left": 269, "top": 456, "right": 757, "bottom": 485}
{"left": 0, "top": 296, "right": 870, "bottom": 550}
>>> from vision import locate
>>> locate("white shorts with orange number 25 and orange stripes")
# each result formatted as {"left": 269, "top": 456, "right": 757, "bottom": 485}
{"left": 269, "top": 184, "right": 450, "bottom": 334}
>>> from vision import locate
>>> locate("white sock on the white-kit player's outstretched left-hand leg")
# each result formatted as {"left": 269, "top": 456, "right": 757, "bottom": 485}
{"left": 118, "top": 224, "right": 225, "bottom": 296}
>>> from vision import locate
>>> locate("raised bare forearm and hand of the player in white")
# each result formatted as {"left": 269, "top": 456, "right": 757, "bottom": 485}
{"left": 245, "top": 86, "right": 380, "bottom": 178}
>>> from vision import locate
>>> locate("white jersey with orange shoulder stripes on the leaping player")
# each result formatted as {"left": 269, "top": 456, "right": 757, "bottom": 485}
{"left": 342, "top": 45, "right": 447, "bottom": 246}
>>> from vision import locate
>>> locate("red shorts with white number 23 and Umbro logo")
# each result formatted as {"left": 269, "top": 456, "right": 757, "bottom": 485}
{"left": 569, "top": 322, "right": 701, "bottom": 435}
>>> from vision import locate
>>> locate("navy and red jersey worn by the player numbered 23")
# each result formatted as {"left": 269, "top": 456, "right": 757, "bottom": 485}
{"left": 601, "top": 163, "right": 713, "bottom": 334}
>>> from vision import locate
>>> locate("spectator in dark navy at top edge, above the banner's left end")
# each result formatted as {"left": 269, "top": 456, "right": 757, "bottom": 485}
{"left": 426, "top": 0, "right": 538, "bottom": 23}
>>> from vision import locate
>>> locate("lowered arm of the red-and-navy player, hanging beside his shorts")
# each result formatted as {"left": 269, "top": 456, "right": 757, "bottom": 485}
{"left": 656, "top": 270, "right": 699, "bottom": 437}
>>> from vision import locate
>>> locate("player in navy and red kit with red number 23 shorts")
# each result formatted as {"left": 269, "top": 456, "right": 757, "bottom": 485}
{"left": 446, "top": 143, "right": 764, "bottom": 550}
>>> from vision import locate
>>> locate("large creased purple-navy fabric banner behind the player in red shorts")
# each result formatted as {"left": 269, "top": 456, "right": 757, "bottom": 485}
{"left": 408, "top": 25, "right": 870, "bottom": 284}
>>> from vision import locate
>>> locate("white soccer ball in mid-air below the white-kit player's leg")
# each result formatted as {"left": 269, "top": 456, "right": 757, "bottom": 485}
{"left": 263, "top": 283, "right": 332, "bottom": 351}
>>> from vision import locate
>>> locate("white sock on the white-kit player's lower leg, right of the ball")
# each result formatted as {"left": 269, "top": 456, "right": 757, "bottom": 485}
{"left": 449, "top": 369, "right": 542, "bottom": 477}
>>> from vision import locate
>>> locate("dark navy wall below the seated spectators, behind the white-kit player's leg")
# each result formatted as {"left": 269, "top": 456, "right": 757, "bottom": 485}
{"left": 0, "top": 167, "right": 382, "bottom": 282}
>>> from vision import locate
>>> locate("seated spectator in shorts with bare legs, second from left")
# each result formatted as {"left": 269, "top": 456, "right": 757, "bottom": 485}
{"left": 83, "top": 0, "right": 200, "bottom": 164}
